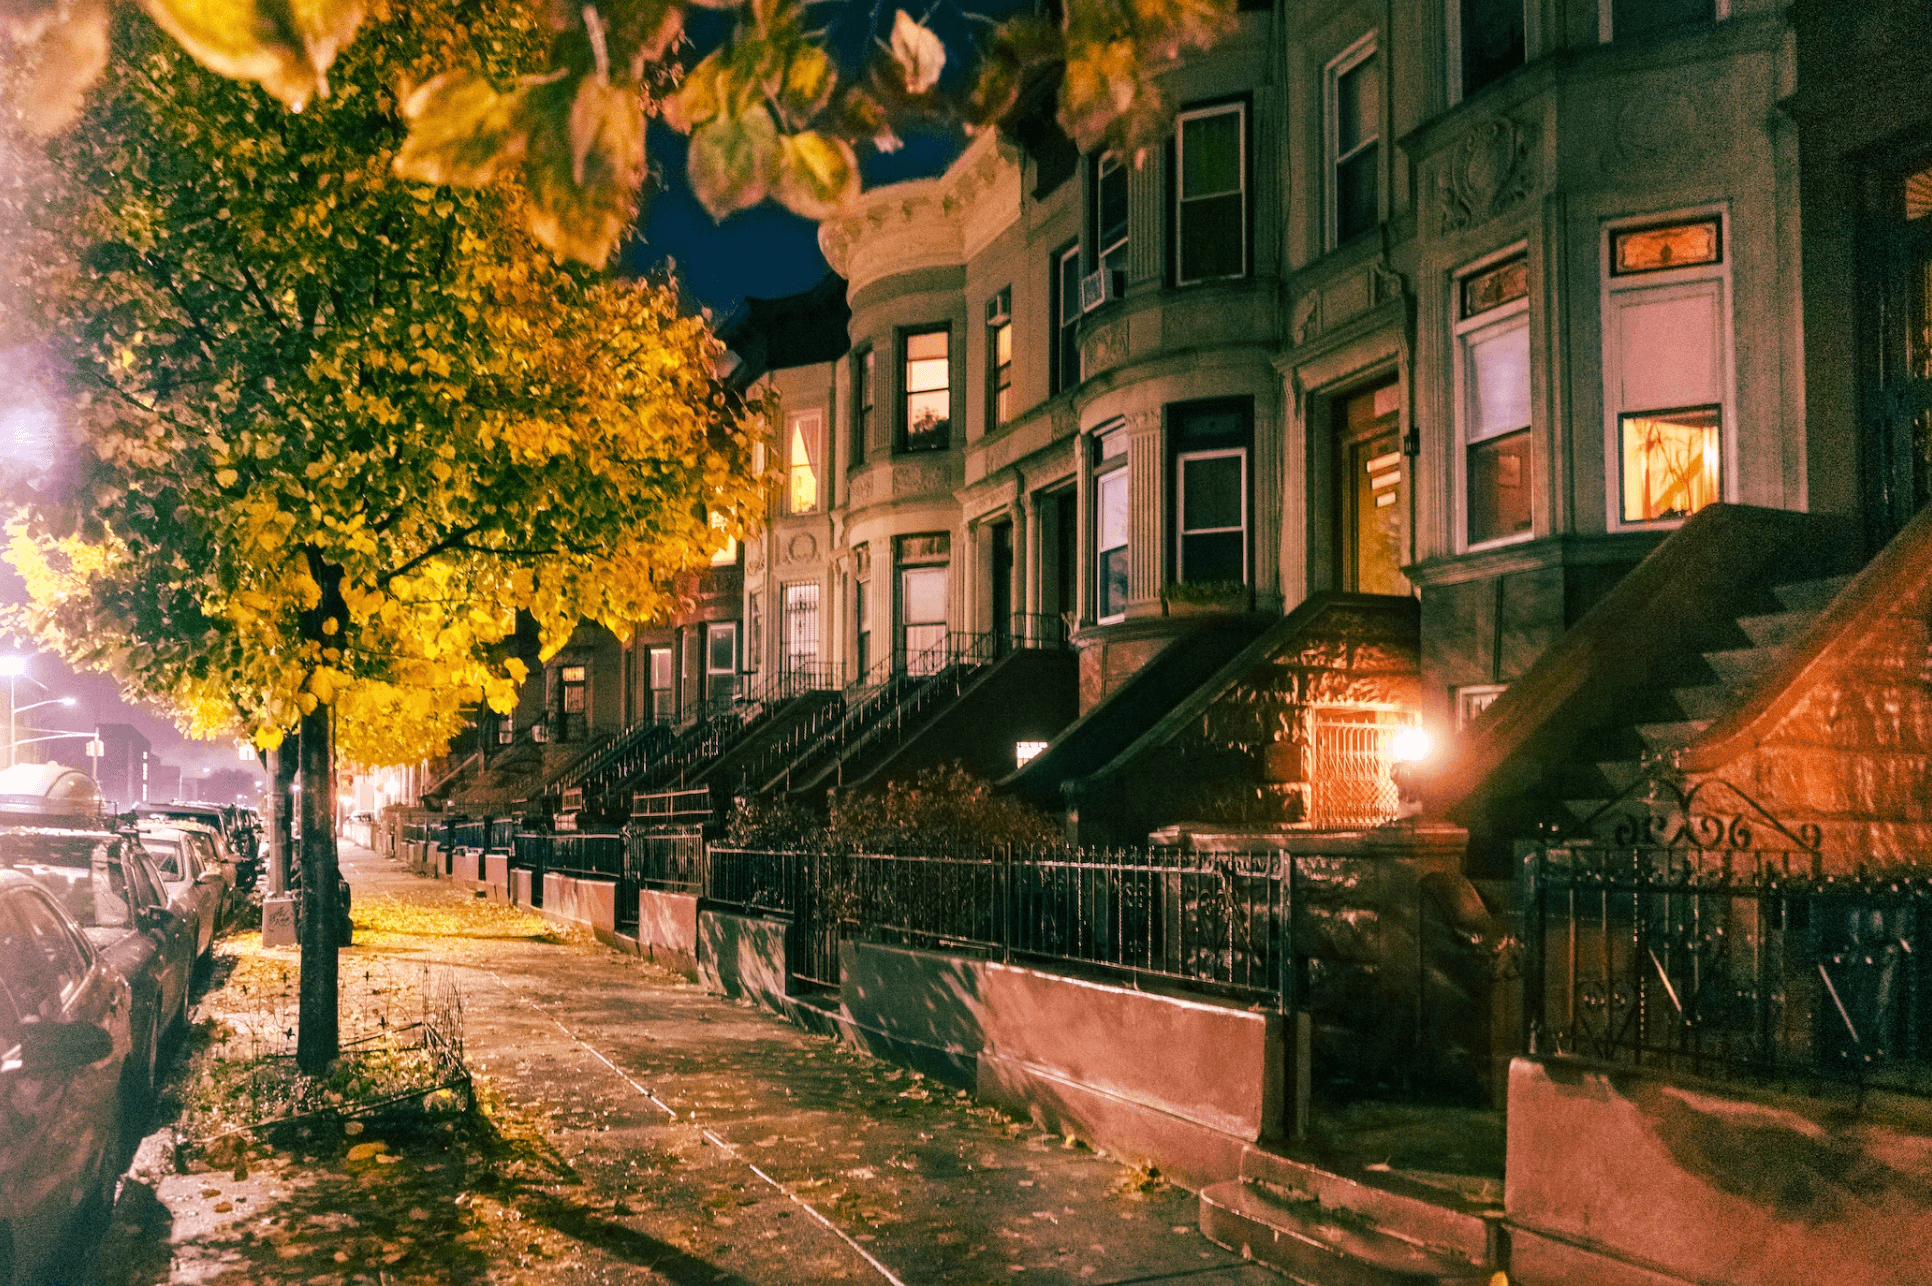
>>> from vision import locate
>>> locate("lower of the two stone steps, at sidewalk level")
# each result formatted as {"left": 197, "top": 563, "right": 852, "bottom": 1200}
{"left": 1202, "top": 1180, "right": 1488, "bottom": 1286}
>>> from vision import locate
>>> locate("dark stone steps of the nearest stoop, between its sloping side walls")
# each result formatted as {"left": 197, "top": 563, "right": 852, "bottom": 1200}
{"left": 1549, "top": 575, "right": 1851, "bottom": 821}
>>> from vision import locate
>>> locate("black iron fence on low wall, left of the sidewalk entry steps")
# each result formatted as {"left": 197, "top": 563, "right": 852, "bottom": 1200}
{"left": 703, "top": 848, "right": 1298, "bottom": 1006}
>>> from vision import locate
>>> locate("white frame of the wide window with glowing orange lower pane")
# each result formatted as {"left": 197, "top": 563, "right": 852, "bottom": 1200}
{"left": 1598, "top": 205, "right": 1739, "bottom": 531}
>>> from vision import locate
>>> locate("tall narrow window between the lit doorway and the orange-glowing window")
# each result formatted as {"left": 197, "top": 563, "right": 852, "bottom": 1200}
{"left": 1457, "top": 257, "right": 1532, "bottom": 546}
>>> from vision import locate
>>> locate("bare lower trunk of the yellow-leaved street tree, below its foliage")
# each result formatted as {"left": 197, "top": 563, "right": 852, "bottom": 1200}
{"left": 296, "top": 705, "right": 342, "bottom": 1076}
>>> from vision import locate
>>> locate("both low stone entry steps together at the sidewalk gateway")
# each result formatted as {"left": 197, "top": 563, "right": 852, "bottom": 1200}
{"left": 1200, "top": 1147, "right": 1503, "bottom": 1286}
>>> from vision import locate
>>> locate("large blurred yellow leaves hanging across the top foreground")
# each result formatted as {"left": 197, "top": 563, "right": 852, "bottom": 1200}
{"left": 0, "top": 0, "right": 1236, "bottom": 266}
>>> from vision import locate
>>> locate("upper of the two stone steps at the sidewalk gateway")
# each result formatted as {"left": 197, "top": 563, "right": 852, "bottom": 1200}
{"left": 1240, "top": 1147, "right": 1501, "bottom": 1263}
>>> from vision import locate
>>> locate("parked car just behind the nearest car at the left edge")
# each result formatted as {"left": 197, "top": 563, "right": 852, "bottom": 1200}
{"left": 0, "top": 828, "right": 195, "bottom": 1110}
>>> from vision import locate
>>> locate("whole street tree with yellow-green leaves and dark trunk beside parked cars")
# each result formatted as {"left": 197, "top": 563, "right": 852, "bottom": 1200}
{"left": 0, "top": 0, "right": 763, "bottom": 1070}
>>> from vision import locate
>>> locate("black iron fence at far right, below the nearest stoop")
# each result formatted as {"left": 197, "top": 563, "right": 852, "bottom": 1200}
{"left": 1524, "top": 844, "right": 1932, "bottom": 1095}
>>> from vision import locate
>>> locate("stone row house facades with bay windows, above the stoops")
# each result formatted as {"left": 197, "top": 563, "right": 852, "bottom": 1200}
{"left": 744, "top": 0, "right": 1861, "bottom": 822}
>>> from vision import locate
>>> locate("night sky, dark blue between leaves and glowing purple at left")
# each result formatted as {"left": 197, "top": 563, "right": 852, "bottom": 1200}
{"left": 0, "top": 0, "right": 996, "bottom": 780}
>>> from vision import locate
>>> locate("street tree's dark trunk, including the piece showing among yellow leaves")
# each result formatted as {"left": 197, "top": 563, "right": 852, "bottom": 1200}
{"left": 296, "top": 546, "right": 348, "bottom": 1076}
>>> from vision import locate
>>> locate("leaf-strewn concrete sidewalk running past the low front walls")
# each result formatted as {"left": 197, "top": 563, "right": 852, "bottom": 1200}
{"left": 108, "top": 848, "right": 1281, "bottom": 1286}
